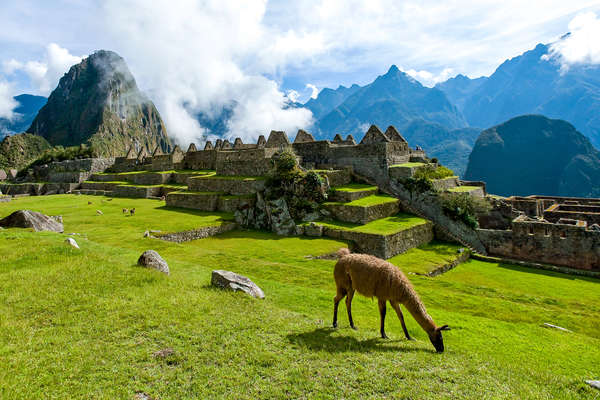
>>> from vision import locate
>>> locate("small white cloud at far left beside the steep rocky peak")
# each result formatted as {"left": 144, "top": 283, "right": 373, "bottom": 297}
{"left": 3, "top": 43, "right": 82, "bottom": 96}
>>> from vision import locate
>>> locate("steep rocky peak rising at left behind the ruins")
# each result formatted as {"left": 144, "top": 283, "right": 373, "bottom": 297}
{"left": 27, "top": 50, "right": 171, "bottom": 156}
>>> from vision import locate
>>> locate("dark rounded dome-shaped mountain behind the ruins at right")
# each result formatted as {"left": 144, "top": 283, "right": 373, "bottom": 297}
{"left": 465, "top": 115, "right": 600, "bottom": 197}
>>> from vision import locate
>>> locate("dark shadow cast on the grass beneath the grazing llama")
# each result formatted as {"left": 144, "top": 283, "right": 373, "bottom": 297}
{"left": 287, "top": 328, "right": 435, "bottom": 353}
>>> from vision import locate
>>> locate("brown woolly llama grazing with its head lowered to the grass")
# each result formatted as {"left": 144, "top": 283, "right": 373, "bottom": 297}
{"left": 333, "top": 249, "right": 450, "bottom": 353}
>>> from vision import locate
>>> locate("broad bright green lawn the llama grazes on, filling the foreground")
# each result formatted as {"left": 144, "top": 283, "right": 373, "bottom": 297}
{"left": 0, "top": 196, "right": 600, "bottom": 399}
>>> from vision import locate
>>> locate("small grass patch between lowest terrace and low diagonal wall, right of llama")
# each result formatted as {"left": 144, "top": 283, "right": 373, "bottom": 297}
{"left": 388, "top": 242, "right": 462, "bottom": 274}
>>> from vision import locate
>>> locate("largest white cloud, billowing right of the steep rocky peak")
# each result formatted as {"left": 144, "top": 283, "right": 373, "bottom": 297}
{"left": 104, "top": 0, "right": 314, "bottom": 145}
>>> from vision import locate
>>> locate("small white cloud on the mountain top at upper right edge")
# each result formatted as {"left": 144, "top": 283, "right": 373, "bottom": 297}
{"left": 545, "top": 12, "right": 600, "bottom": 70}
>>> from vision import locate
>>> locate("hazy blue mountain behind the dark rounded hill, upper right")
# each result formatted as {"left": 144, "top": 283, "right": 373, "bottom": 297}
{"left": 436, "top": 44, "right": 600, "bottom": 147}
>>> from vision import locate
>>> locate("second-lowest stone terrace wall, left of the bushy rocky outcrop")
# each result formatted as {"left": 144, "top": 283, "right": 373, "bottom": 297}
{"left": 188, "top": 175, "right": 266, "bottom": 195}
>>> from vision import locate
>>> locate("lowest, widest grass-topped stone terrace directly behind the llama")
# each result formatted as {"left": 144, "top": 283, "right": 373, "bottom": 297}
{"left": 304, "top": 214, "right": 434, "bottom": 259}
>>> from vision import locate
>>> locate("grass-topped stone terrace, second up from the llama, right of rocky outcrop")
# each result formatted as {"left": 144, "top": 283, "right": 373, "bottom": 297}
{"left": 324, "top": 195, "right": 400, "bottom": 224}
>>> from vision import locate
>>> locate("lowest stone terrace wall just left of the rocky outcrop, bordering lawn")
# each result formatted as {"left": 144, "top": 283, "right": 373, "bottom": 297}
{"left": 166, "top": 191, "right": 256, "bottom": 213}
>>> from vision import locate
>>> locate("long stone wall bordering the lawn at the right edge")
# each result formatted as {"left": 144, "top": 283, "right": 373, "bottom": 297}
{"left": 478, "top": 221, "right": 600, "bottom": 271}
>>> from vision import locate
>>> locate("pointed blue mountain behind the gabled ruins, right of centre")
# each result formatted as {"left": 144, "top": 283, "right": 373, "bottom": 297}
{"left": 313, "top": 65, "right": 467, "bottom": 138}
